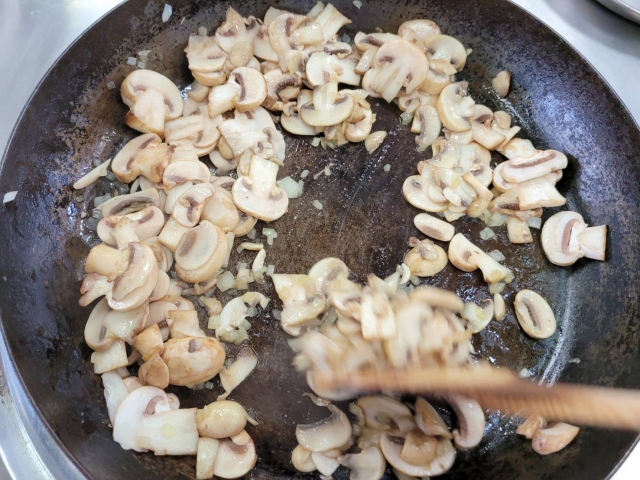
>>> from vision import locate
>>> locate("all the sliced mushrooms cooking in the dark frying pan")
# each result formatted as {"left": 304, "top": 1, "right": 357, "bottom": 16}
{"left": 74, "top": 2, "right": 606, "bottom": 480}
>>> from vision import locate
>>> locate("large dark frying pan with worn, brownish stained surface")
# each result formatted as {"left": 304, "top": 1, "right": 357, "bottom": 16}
{"left": 0, "top": 0, "right": 640, "bottom": 479}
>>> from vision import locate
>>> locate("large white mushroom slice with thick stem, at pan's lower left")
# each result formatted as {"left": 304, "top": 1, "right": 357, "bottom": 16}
{"left": 113, "top": 386, "right": 198, "bottom": 455}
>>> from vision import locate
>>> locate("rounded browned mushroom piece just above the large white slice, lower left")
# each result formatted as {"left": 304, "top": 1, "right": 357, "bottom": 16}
{"left": 162, "top": 337, "right": 226, "bottom": 385}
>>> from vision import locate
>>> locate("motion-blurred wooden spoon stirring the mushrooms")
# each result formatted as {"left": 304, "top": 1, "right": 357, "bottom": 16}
{"left": 313, "top": 366, "right": 640, "bottom": 431}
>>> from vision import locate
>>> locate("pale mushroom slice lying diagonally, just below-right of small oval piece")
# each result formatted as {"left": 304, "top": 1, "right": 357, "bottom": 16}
{"left": 448, "top": 233, "right": 513, "bottom": 283}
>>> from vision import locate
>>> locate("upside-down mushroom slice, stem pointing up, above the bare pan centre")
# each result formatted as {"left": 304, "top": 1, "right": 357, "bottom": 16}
{"left": 299, "top": 82, "right": 354, "bottom": 127}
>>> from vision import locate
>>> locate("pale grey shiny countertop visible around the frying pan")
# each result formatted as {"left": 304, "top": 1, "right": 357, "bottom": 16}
{"left": 0, "top": 0, "right": 640, "bottom": 480}
